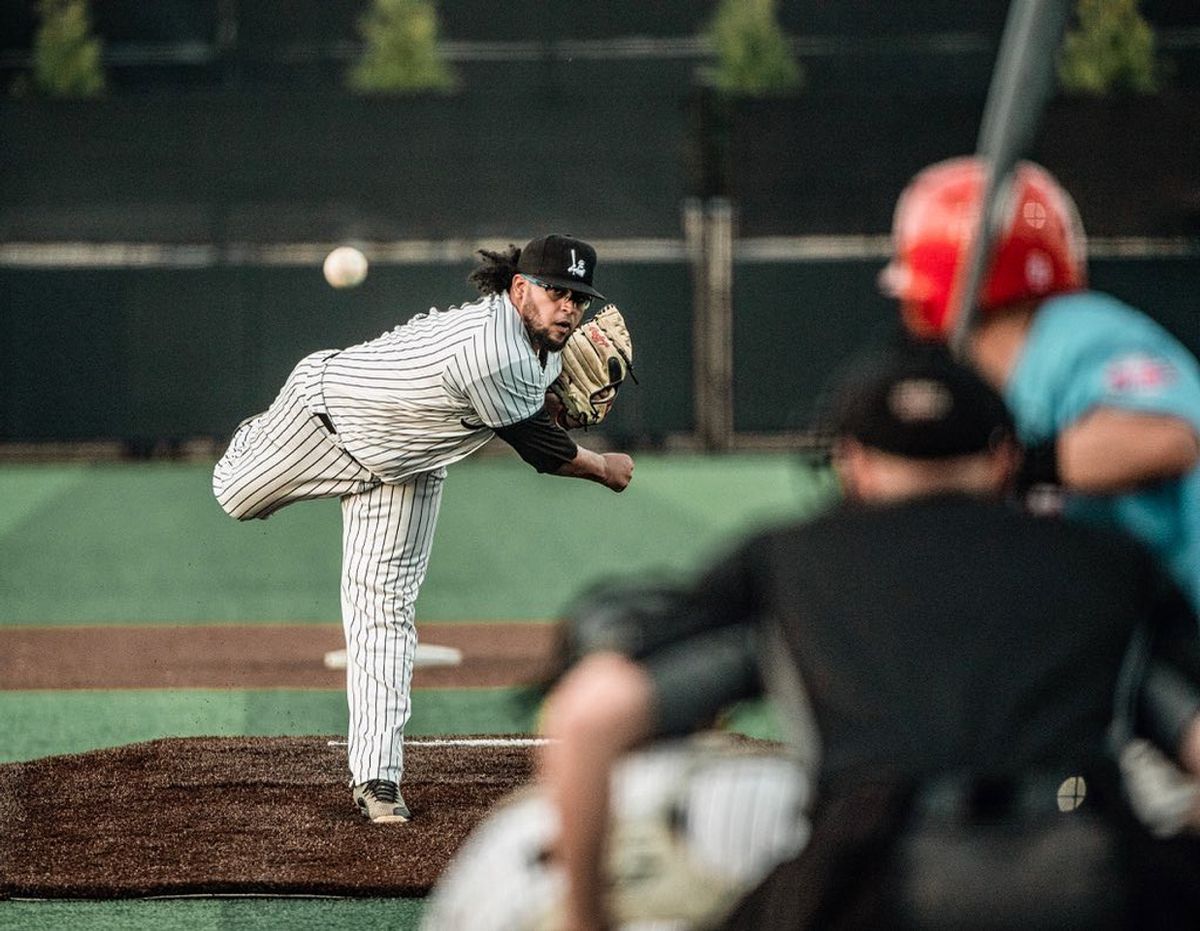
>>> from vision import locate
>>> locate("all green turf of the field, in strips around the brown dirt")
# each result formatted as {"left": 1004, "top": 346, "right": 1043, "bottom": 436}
{"left": 0, "top": 455, "right": 829, "bottom": 931}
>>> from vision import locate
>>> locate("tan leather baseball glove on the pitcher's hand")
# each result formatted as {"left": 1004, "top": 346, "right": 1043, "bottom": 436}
{"left": 550, "top": 304, "right": 637, "bottom": 428}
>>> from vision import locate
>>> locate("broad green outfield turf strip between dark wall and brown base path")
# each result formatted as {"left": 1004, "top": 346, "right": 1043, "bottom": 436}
{"left": 0, "top": 455, "right": 826, "bottom": 624}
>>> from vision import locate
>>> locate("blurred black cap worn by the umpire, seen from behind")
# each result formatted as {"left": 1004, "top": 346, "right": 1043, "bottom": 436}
{"left": 829, "top": 347, "right": 1015, "bottom": 460}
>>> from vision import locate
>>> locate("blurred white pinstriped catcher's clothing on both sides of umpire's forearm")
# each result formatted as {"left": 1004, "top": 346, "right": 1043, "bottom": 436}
{"left": 421, "top": 733, "right": 809, "bottom": 931}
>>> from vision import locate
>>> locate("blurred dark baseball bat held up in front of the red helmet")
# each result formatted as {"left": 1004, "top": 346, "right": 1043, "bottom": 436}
{"left": 950, "top": 0, "right": 1072, "bottom": 359}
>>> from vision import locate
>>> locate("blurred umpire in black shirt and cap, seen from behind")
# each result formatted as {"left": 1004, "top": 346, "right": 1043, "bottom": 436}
{"left": 541, "top": 352, "right": 1200, "bottom": 931}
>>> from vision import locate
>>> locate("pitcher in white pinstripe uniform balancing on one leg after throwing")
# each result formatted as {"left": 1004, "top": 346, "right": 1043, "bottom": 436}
{"left": 212, "top": 235, "right": 634, "bottom": 822}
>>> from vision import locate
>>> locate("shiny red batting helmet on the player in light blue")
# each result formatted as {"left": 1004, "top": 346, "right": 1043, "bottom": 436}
{"left": 880, "top": 157, "right": 1087, "bottom": 338}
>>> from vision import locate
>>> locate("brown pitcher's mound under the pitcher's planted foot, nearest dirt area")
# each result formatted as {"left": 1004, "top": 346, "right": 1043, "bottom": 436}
{"left": 0, "top": 737, "right": 533, "bottom": 899}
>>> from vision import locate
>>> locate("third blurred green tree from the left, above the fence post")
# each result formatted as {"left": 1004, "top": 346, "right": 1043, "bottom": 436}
{"left": 707, "top": 0, "right": 804, "bottom": 97}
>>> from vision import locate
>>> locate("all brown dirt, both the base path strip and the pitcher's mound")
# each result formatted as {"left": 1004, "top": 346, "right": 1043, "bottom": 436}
{"left": 0, "top": 623, "right": 554, "bottom": 899}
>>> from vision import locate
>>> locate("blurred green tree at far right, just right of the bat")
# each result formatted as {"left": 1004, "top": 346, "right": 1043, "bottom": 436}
{"left": 1058, "top": 0, "right": 1158, "bottom": 96}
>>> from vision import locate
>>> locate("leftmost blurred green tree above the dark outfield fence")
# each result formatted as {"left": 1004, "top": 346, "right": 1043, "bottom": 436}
{"left": 22, "top": 0, "right": 106, "bottom": 97}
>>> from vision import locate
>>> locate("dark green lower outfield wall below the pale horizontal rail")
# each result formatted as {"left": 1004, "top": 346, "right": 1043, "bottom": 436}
{"left": 0, "top": 253, "right": 1200, "bottom": 445}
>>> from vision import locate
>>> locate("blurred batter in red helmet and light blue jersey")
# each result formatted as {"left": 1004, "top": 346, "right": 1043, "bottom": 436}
{"left": 881, "top": 157, "right": 1200, "bottom": 606}
